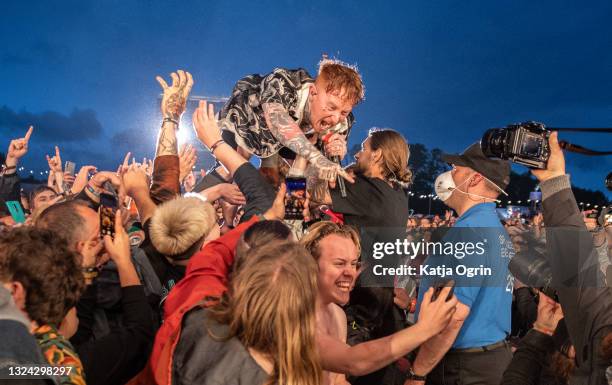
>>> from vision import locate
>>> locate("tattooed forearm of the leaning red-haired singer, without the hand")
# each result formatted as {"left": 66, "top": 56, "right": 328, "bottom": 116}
{"left": 263, "top": 103, "right": 320, "bottom": 160}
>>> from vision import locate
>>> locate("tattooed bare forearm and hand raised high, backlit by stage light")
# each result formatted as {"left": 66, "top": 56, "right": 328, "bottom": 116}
{"left": 155, "top": 70, "right": 193, "bottom": 157}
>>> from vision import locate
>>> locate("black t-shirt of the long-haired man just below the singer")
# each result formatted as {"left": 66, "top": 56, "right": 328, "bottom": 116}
{"left": 330, "top": 175, "right": 408, "bottom": 385}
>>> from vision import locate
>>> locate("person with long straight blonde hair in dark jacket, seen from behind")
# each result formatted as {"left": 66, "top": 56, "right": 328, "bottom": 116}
{"left": 172, "top": 241, "right": 322, "bottom": 385}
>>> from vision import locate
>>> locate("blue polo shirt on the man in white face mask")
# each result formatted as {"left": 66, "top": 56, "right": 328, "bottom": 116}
{"left": 417, "top": 203, "right": 514, "bottom": 348}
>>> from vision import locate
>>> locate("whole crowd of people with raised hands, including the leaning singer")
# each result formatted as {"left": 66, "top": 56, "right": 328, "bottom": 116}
{"left": 0, "top": 59, "right": 612, "bottom": 385}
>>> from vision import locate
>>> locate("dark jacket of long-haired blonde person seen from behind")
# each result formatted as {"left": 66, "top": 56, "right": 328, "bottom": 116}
{"left": 172, "top": 307, "right": 268, "bottom": 385}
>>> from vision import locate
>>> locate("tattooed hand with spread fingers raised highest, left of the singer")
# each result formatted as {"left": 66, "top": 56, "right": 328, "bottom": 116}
{"left": 155, "top": 70, "right": 193, "bottom": 124}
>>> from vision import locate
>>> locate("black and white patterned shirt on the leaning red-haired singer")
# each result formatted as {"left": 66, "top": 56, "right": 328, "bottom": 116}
{"left": 219, "top": 68, "right": 354, "bottom": 158}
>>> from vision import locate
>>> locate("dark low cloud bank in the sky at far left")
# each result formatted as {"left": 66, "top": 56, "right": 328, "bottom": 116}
{"left": 0, "top": 106, "right": 102, "bottom": 143}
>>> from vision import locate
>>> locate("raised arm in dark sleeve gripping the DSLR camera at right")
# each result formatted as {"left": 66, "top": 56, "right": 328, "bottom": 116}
{"left": 532, "top": 132, "right": 612, "bottom": 384}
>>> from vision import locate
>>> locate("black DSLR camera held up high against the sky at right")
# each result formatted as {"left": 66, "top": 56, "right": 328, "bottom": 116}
{"left": 480, "top": 122, "right": 550, "bottom": 169}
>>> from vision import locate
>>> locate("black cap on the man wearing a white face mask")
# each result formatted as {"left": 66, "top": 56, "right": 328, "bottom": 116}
{"left": 442, "top": 142, "right": 510, "bottom": 190}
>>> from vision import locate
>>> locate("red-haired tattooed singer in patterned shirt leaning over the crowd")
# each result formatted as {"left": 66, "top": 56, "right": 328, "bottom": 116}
{"left": 214, "top": 59, "right": 364, "bottom": 180}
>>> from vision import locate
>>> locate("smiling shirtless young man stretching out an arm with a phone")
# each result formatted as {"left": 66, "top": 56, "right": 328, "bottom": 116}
{"left": 300, "top": 221, "right": 457, "bottom": 384}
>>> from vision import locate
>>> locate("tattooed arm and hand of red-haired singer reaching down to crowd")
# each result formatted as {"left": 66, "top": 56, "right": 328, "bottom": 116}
{"left": 262, "top": 103, "right": 352, "bottom": 181}
